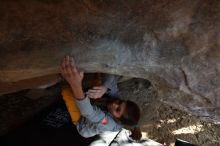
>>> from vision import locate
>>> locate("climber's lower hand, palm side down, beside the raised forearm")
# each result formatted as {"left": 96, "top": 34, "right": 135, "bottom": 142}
{"left": 88, "top": 86, "right": 107, "bottom": 99}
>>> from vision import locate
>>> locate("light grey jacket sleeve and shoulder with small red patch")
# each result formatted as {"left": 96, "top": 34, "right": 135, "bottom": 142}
{"left": 76, "top": 96, "right": 122, "bottom": 137}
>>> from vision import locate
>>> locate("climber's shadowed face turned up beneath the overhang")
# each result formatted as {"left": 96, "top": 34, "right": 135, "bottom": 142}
{"left": 107, "top": 99, "right": 126, "bottom": 119}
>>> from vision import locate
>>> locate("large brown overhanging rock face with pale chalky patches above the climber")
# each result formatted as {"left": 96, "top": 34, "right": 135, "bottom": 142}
{"left": 0, "top": 0, "right": 220, "bottom": 123}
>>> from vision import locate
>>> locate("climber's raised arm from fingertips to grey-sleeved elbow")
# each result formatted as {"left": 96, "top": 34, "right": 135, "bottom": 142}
{"left": 60, "top": 56, "right": 105, "bottom": 122}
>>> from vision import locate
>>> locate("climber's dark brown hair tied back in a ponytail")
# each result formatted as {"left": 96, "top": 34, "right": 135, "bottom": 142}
{"left": 119, "top": 100, "right": 142, "bottom": 140}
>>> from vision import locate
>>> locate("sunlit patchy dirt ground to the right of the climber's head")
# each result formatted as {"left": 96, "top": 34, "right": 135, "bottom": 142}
{"left": 119, "top": 79, "right": 220, "bottom": 146}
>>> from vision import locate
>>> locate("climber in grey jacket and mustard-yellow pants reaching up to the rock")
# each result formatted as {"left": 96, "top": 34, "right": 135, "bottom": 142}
{"left": 60, "top": 56, "right": 141, "bottom": 140}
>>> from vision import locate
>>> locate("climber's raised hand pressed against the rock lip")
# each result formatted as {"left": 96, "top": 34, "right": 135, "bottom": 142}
{"left": 60, "top": 56, "right": 83, "bottom": 88}
